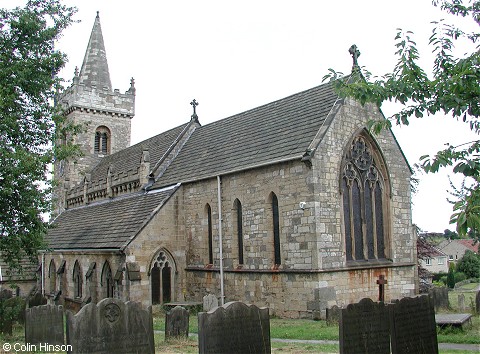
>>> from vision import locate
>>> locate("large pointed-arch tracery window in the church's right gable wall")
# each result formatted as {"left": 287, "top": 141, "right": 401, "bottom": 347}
{"left": 341, "top": 135, "right": 388, "bottom": 261}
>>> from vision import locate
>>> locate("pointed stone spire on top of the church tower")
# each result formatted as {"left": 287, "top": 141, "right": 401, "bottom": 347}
{"left": 80, "top": 11, "right": 112, "bottom": 91}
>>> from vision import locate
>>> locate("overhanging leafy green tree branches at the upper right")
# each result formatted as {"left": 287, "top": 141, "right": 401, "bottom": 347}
{"left": 324, "top": 0, "right": 480, "bottom": 238}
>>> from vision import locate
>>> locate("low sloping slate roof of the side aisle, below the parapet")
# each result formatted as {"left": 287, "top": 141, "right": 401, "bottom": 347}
{"left": 46, "top": 186, "right": 178, "bottom": 250}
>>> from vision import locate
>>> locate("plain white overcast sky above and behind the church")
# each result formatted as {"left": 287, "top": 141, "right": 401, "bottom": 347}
{"left": 1, "top": 0, "right": 480, "bottom": 232}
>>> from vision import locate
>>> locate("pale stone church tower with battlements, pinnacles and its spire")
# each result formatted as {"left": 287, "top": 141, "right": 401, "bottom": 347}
{"left": 54, "top": 12, "right": 135, "bottom": 215}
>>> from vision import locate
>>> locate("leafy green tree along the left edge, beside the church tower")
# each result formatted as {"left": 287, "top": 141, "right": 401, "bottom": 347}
{"left": 0, "top": 0, "right": 77, "bottom": 282}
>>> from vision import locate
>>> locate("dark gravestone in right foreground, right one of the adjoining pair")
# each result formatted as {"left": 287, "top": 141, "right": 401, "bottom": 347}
{"left": 390, "top": 295, "right": 438, "bottom": 354}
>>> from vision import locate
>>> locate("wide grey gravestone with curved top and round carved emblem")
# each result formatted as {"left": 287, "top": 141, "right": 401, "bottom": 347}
{"left": 66, "top": 298, "right": 155, "bottom": 353}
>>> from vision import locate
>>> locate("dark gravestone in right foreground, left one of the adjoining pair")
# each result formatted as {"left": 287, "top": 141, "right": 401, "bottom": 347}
{"left": 339, "top": 298, "right": 390, "bottom": 354}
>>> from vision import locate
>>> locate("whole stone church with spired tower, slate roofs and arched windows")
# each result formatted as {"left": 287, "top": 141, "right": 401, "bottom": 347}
{"left": 41, "top": 14, "right": 416, "bottom": 317}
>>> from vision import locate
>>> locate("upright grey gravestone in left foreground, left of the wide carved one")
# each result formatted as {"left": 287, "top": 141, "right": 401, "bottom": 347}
{"left": 25, "top": 305, "right": 64, "bottom": 345}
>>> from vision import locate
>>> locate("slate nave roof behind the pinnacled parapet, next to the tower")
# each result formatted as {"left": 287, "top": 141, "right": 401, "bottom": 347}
{"left": 90, "top": 123, "right": 188, "bottom": 183}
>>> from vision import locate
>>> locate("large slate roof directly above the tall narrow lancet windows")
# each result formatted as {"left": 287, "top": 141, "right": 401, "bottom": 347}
{"left": 153, "top": 83, "right": 338, "bottom": 188}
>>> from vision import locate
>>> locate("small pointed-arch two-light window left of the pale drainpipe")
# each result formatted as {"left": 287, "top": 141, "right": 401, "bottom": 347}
{"left": 150, "top": 250, "right": 175, "bottom": 305}
